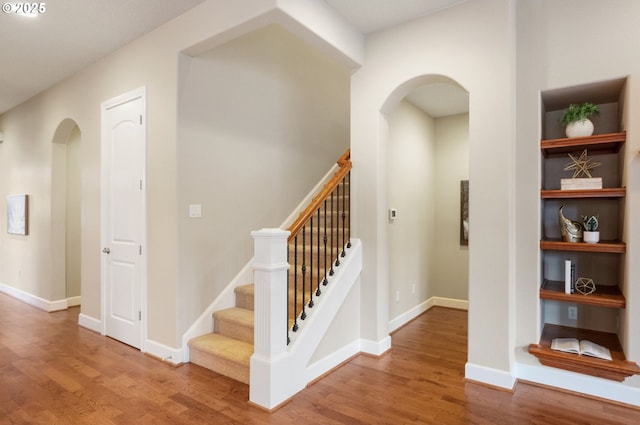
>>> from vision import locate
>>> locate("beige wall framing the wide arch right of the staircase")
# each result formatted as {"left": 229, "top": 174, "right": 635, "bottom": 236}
{"left": 351, "top": 0, "right": 515, "bottom": 374}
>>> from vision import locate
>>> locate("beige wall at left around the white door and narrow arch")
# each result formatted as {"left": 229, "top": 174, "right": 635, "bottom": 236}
{"left": 0, "top": 0, "right": 362, "bottom": 347}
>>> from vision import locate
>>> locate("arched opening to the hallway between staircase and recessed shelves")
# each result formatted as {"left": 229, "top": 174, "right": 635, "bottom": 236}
{"left": 384, "top": 76, "right": 469, "bottom": 330}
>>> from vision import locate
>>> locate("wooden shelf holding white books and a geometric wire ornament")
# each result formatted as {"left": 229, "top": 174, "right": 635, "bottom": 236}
{"left": 540, "top": 280, "right": 627, "bottom": 308}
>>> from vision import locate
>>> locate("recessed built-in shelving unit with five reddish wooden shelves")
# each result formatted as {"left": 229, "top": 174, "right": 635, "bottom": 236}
{"left": 529, "top": 79, "right": 640, "bottom": 381}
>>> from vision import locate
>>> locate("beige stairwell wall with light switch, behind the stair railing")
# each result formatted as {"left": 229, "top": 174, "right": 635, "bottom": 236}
{"left": 177, "top": 26, "right": 350, "bottom": 332}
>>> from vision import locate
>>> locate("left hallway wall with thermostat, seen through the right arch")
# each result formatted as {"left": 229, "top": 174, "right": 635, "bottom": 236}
{"left": 386, "top": 101, "right": 437, "bottom": 319}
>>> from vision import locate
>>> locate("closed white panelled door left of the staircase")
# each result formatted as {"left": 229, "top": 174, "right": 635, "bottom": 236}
{"left": 101, "top": 89, "right": 146, "bottom": 348}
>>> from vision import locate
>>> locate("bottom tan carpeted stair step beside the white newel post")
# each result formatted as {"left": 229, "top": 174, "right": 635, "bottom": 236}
{"left": 189, "top": 333, "right": 253, "bottom": 384}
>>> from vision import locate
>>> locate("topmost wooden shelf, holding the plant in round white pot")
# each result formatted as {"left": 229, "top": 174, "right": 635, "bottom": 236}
{"left": 540, "top": 132, "right": 627, "bottom": 157}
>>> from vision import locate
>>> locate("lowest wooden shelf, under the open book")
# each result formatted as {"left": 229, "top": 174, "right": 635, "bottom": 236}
{"left": 529, "top": 324, "right": 640, "bottom": 382}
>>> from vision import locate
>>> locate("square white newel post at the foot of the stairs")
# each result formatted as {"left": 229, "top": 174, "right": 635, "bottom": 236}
{"left": 249, "top": 229, "right": 289, "bottom": 408}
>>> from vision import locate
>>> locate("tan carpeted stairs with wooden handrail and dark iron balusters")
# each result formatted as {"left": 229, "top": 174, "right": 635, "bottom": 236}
{"left": 188, "top": 152, "right": 351, "bottom": 384}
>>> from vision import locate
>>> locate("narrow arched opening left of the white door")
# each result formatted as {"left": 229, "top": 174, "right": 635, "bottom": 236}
{"left": 51, "top": 119, "right": 82, "bottom": 306}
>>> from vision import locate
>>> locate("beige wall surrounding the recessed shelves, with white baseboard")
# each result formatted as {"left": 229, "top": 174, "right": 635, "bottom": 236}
{"left": 516, "top": 0, "right": 640, "bottom": 398}
